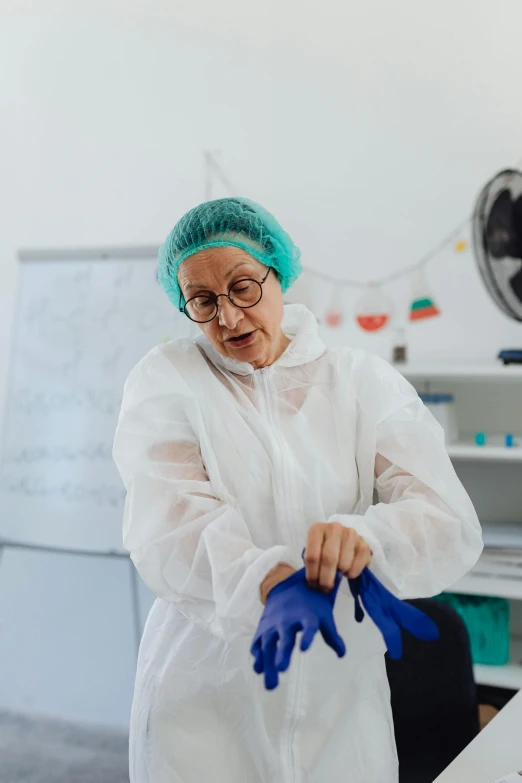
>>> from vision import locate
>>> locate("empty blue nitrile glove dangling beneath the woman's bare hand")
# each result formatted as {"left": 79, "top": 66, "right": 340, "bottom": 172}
{"left": 348, "top": 568, "right": 439, "bottom": 661}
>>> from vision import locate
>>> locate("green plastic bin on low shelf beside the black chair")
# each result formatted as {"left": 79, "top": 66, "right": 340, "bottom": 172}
{"left": 430, "top": 593, "right": 510, "bottom": 666}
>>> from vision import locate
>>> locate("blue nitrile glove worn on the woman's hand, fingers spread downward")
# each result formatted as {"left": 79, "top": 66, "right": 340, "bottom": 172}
{"left": 250, "top": 568, "right": 346, "bottom": 690}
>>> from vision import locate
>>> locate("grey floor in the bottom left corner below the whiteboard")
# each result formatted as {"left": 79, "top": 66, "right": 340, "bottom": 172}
{"left": 0, "top": 712, "right": 129, "bottom": 783}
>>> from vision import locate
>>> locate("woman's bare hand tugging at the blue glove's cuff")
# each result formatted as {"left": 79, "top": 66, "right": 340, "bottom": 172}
{"left": 304, "top": 522, "right": 372, "bottom": 592}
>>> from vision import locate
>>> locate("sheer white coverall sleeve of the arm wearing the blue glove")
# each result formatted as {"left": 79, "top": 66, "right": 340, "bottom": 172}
{"left": 113, "top": 346, "right": 293, "bottom": 640}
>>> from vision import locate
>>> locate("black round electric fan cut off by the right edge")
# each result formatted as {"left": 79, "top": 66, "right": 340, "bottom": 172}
{"left": 473, "top": 169, "right": 522, "bottom": 364}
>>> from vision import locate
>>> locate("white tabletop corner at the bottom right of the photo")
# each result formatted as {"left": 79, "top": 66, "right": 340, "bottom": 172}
{"left": 434, "top": 691, "right": 522, "bottom": 783}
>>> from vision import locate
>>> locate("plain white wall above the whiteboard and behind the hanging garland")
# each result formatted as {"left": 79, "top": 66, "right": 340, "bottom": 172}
{"left": 0, "top": 0, "right": 522, "bottom": 720}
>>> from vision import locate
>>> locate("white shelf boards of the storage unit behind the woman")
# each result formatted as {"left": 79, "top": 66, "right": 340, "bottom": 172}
{"left": 397, "top": 362, "right": 522, "bottom": 690}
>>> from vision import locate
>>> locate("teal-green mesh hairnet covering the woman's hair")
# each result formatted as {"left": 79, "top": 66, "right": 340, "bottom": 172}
{"left": 158, "top": 197, "right": 303, "bottom": 307}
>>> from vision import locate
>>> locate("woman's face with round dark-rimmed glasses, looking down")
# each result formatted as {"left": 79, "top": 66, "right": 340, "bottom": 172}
{"left": 178, "top": 247, "right": 290, "bottom": 369}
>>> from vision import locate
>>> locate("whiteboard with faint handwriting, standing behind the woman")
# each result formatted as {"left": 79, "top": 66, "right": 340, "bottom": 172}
{"left": 0, "top": 248, "right": 197, "bottom": 552}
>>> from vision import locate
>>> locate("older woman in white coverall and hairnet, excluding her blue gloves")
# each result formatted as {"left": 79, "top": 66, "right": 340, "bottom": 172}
{"left": 114, "top": 198, "right": 482, "bottom": 783}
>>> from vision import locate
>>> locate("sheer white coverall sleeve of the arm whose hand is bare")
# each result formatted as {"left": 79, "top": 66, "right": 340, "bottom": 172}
{"left": 330, "top": 357, "right": 483, "bottom": 598}
